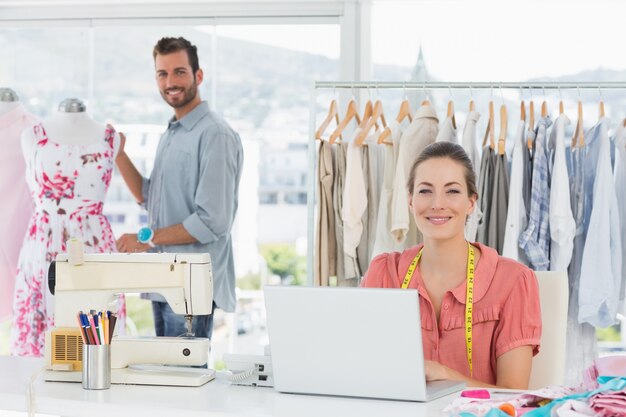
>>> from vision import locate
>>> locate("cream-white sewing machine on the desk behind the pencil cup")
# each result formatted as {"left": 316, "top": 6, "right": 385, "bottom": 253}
{"left": 45, "top": 251, "right": 215, "bottom": 386}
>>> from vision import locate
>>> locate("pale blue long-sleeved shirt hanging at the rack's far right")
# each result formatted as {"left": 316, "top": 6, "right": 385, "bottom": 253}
{"left": 578, "top": 117, "right": 622, "bottom": 327}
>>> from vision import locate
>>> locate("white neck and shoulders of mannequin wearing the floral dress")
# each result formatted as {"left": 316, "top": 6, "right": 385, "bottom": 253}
{"left": 42, "top": 98, "right": 106, "bottom": 145}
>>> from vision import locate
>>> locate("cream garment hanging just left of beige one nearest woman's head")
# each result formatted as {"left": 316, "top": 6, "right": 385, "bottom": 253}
{"left": 372, "top": 119, "right": 404, "bottom": 258}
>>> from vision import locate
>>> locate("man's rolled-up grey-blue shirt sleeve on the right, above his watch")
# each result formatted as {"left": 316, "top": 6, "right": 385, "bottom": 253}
{"left": 182, "top": 130, "right": 243, "bottom": 244}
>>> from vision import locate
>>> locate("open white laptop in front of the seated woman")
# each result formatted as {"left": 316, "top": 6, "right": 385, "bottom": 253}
{"left": 264, "top": 286, "right": 465, "bottom": 401}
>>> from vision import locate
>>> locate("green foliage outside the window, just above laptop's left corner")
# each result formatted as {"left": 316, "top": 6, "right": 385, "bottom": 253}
{"left": 259, "top": 244, "right": 306, "bottom": 285}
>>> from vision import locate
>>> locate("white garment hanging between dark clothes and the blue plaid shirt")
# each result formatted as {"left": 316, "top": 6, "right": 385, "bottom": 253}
{"left": 502, "top": 120, "right": 524, "bottom": 265}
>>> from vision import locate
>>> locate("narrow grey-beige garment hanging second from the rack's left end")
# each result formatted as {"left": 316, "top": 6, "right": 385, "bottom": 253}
{"left": 333, "top": 141, "right": 361, "bottom": 286}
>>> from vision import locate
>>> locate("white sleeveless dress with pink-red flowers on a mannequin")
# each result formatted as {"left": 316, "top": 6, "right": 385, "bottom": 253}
{"left": 11, "top": 123, "right": 125, "bottom": 356}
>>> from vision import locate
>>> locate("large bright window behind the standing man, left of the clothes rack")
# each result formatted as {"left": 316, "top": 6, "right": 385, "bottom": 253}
{"left": 0, "top": 18, "right": 340, "bottom": 358}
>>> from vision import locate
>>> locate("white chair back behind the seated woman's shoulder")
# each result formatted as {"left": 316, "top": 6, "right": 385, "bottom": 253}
{"left": 528, "top": 271, "right": 569, "bottom": 389}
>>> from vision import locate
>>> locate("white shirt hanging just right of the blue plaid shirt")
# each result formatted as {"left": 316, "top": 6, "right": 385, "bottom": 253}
{"left": 548, "top": 114, "right": 576, "bottom": 271}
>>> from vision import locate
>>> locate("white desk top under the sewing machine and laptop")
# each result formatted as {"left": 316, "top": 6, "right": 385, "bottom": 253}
{"left": 0, "top": 356, "right": 458, "bottom": 417}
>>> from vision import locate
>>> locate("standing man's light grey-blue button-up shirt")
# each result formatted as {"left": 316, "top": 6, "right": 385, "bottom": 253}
{"left": 142, "top": 101, "right": 243, "bottom": 312}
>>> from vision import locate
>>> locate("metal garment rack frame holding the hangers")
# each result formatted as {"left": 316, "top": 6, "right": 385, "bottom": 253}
{"left": 307, "top": 81, "right": 626, "bottom": 285}
